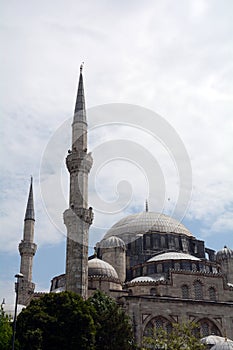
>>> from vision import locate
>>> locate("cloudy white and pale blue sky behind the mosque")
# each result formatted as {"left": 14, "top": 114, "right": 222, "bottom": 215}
{"left": 0, "top": 0, "right": 233, "bottom": 309}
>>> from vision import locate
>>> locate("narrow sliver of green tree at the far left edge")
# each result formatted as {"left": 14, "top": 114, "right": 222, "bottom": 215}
{"left": 0, "top": 305, "right": 12, "bottom": 350}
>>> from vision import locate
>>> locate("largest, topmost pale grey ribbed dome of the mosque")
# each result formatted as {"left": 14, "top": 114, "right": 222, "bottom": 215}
{"left": 104, "top": 211, "right": 193, "bottom": 243}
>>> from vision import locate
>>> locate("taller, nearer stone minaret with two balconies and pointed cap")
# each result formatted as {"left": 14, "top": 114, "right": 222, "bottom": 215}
{"left": 64, "top": 65, "right": 93, "bottom": 299}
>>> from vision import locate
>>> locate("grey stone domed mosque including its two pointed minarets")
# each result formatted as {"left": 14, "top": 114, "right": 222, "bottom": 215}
{"left": 18, "top": 66, "right": 233, "bottom": 344}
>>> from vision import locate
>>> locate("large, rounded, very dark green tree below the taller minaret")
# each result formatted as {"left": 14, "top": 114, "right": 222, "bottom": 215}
{"left": 16, "top": 292, "right": 95, "bottom": 350}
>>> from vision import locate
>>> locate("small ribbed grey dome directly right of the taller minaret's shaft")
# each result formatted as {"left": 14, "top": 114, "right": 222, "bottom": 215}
{"left": 88, "top": 258, "right": 118, "bottom": 279}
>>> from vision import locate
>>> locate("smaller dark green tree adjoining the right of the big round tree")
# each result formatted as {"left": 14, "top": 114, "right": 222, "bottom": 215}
{"left": 89, "top": 291, "right": 134, "bottom": 350}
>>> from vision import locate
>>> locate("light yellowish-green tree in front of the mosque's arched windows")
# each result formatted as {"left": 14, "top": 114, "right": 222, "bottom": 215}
{"left": 143, "top": 322, "right": 205, "bottom": 350}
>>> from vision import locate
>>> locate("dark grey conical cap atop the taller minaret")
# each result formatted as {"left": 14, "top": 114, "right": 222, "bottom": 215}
{"left": 74, "top": 64, "right": 86, "bottom": 123}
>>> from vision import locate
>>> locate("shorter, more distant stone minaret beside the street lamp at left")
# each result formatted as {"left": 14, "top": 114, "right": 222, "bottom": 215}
{"left": 18, "top": 178, "right": 37, "bottom": 305}
